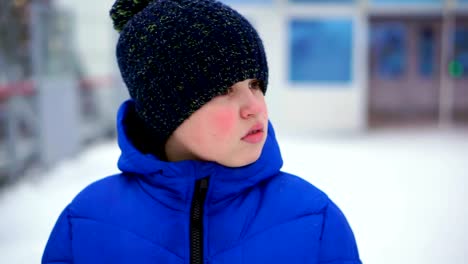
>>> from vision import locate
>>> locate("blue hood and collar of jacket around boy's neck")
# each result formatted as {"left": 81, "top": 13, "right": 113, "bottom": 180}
{"left": 117, "top": 100, "right": 283, "bottom": 210}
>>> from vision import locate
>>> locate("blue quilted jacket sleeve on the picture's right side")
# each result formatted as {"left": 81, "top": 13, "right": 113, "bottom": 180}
{"left": 319, "top": 201, "right": 362, "bottom": 264}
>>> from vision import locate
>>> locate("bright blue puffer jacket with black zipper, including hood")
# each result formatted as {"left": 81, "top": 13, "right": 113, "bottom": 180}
{"left": 42, "top": 101, "right": 361, "bottom": 264}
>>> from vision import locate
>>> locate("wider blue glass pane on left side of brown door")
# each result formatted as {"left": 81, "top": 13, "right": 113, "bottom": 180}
{"left": 370, "top": 22, "right": 407, "bottom": 79}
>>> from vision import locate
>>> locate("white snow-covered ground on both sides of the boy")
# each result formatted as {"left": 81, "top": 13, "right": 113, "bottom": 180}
{"left": 0, "top": 129, "right": 468, "bottom": 264}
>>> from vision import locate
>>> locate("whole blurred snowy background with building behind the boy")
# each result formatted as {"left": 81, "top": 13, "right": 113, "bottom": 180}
{"left": 0, "top": 0, "right": 468, "bottom": 264}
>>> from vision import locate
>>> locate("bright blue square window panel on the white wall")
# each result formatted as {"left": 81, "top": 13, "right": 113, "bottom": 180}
{"left": 289, "top": 19, "right": 353, "bottom": 83}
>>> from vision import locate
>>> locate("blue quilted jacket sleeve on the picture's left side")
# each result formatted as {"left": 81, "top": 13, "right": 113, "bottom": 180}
{"left": 42, "top": 207, "right": 73, "bottom": 264}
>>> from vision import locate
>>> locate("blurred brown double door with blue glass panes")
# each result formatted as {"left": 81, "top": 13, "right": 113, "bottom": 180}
{"left": 368, "top": 17, "right": 441, "bottom": 127}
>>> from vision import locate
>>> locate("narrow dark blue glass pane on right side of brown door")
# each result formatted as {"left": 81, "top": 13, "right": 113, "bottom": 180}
{"left": 419, "top": 27, "right": 435, "bottom": 77}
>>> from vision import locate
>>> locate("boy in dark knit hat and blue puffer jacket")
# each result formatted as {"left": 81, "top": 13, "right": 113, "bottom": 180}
{"left": 42, "top": 0, "right": 361, "bottom": 264}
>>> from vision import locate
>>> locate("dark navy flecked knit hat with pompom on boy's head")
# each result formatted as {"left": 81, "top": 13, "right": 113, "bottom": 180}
{"left": 110, "top": 0, "right": 268, "bottom": 148}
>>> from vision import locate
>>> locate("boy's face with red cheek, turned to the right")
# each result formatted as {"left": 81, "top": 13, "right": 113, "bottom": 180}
{"left": 166, "top": 79, "right": 268, "bottom": 167}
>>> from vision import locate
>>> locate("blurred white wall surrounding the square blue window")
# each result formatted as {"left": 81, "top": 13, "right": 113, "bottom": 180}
{"left": 234, "top": 4, "right": 367, "bottom": 135}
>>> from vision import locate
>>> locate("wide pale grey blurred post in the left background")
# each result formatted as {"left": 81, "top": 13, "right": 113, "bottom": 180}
{"left": 31, "top": 3, "right": 80, "bottom": 166}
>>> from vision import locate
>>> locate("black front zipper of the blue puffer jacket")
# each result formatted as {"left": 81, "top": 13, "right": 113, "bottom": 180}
{"left": 190, "top": 177, "right": 208, "bottom": 264}
